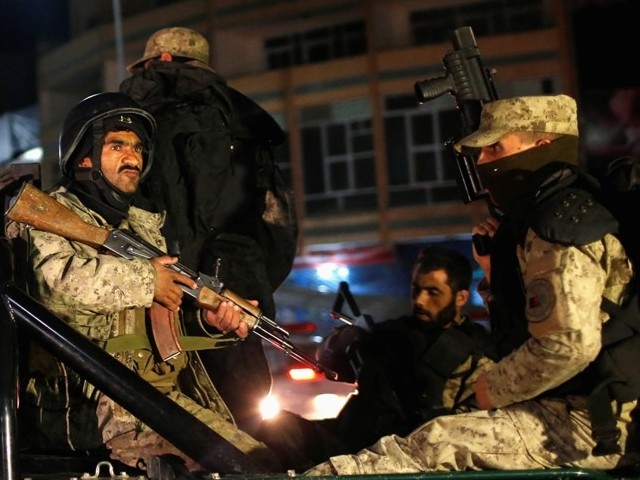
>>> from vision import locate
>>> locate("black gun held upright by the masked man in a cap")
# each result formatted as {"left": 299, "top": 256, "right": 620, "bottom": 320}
{"left": 414, "top": 27, "right": 501, "bottom": 254}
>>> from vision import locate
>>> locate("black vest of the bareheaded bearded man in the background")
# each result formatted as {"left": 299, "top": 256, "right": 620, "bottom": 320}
{"left": 337, "top": 317, "right": 489, "bottom": 451}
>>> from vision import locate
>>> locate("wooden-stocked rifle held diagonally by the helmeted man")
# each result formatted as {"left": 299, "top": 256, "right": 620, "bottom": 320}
{"left": 5, "top": 183, "right": 337, "bottom": 378}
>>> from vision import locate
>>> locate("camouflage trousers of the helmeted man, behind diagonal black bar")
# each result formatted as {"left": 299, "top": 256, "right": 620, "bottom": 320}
{"left": 97, "top": 391, "right": 276, "bottom": 471}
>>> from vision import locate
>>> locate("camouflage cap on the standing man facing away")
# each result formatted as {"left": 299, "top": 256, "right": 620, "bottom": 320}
{"left": 127, "top": 27, "right": 212, "bottom": 73}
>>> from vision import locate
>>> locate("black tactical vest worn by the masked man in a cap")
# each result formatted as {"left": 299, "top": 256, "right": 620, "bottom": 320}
{"left": 490, "top": 169, "right": 640, "bottom": 456}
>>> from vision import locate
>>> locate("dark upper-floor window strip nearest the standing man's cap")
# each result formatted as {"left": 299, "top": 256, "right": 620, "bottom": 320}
{"left": 265, "top": 20, "right": 367, "bottom": 70}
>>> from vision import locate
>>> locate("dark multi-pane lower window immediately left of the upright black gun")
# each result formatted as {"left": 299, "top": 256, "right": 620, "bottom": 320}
{"left": 385, "top": 95, "right": 461, "bottom": 207}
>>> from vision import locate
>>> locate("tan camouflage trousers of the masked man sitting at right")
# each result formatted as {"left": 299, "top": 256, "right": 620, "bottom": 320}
{"left": 305, "top": 399, "right": 634, "bottom": 475}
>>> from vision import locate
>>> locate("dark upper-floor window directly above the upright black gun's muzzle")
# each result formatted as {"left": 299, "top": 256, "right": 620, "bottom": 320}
{"left": 409, "top": 0, "right": 552, "bottom": 45}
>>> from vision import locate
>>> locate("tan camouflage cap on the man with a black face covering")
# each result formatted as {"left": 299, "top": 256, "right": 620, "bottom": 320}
{"left": 455, "top": 95, "right": 578, "bottom": 151}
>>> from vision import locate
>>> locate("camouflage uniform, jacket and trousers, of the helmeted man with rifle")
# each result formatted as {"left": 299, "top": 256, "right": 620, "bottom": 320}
{"left": 14, "top": 188, "right": 271, "bottom": 468}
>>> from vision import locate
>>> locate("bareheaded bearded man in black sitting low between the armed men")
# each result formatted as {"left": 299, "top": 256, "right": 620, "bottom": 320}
{"left": 319, "top": 245, "right": 490, "bottom": 453}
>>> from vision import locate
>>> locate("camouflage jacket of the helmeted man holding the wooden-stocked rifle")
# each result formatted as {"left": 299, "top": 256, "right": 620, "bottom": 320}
{"left": 8, "top": 188, "right": 233, "bottom": 450}
